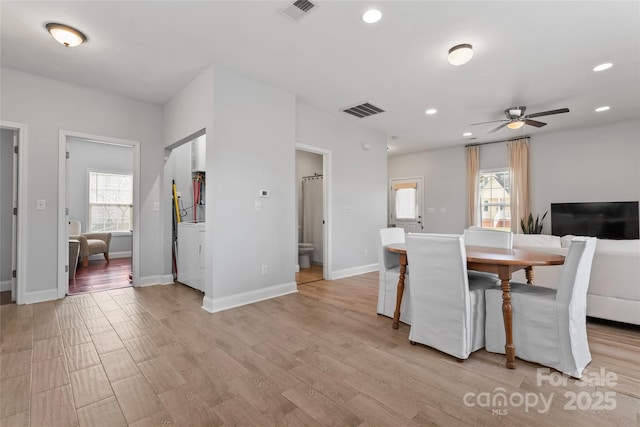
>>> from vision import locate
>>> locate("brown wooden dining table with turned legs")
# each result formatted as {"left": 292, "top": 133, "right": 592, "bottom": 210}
{"left": 385, "top": 243, "right": 564, "bottom": 369}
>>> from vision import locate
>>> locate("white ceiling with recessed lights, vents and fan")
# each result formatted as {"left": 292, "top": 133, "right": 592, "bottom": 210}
{"left": 0, "top": 0, "right": 640, "bottom": 155}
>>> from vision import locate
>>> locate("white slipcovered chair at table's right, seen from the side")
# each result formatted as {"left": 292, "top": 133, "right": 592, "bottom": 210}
{"left": 485, "top": 237, "right": 597, "bottom": 378}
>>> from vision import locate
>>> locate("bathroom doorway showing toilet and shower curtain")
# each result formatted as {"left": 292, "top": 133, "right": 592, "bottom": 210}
{"left": 295, "top": 145, "right": 331, "bottom": 285}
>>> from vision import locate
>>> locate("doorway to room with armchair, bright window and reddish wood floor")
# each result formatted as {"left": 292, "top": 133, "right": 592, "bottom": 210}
{"left": 58, "top": 131, "right": 140, "bottom": 298}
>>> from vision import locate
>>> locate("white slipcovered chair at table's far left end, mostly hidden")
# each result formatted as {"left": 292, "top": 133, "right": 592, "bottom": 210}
{"left": 377, "top": 228, "right": 411, "bottom": 323}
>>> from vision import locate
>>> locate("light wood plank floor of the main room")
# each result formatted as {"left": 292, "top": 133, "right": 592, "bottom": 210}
{"left": 0, "top": 273, "right": 640, "bottom": 427}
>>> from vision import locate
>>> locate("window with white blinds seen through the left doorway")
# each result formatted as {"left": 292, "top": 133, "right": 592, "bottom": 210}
{"left": 87, "top": 171, "right": 133, "bottom": 232}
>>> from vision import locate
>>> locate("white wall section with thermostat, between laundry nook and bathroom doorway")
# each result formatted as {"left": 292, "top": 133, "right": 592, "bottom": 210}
{"left": 207, "top": 67, "right": 297, "bottom": 300}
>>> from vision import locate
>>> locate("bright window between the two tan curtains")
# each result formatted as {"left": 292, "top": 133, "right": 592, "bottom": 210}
{"left": 479, "top": 169, "right": 511, "bottom": 230}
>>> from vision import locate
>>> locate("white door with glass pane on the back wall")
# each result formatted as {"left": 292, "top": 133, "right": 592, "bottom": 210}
{"left": 389, "top": 177, "right": 424, "bottom": 233}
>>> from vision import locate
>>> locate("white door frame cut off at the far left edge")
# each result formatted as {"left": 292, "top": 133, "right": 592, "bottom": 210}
{"left": 0, "top": 120, "right": 27, "bottom": 304}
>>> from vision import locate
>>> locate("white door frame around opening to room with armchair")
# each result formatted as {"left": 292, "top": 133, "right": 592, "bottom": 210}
{"left": 58, "top": 129, "right": 140, "bottom": 298}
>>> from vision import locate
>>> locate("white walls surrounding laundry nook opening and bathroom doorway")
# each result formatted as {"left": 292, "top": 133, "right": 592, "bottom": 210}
{"left": 163, "top": 66, "right": 386, "bottom": 311}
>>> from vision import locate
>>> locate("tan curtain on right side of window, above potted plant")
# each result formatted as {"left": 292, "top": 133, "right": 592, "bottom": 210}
{"left": 509, "top": 138, "right": 531, "bottom": 233}
